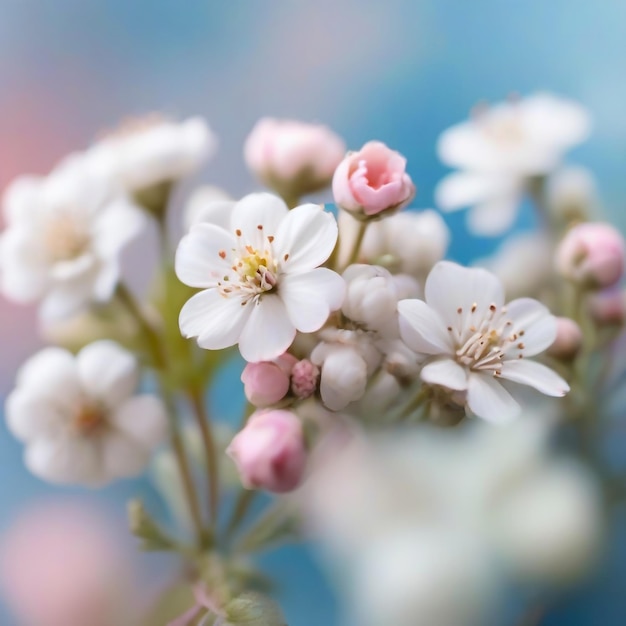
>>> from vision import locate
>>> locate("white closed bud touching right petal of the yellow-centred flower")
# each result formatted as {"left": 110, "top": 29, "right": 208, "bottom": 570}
{"left": 341, "top": 265, "right": 399, "bottom": 338}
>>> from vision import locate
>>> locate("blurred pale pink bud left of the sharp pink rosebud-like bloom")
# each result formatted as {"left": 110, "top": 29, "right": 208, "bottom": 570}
{"left": 244, "top": 117, "right": 346, "bottom": 199}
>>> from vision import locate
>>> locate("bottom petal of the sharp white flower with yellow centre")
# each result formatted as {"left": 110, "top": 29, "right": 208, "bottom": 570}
{"left": 239, "top": 295, "right": 296, "bottom": 363}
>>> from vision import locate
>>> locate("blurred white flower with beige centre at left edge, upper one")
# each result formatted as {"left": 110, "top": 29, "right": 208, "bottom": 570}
{"left": 0, "top": 157, "right": 146, "bottom": 320}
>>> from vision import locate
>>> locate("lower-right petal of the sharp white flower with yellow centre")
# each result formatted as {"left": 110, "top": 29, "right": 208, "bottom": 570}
{"left": 280, "top": 267, "right": 346, "bottom": 333}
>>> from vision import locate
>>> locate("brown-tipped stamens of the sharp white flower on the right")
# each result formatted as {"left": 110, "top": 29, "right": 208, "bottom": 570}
{"left": 448, "top": 303, "right": 525, "bottom": 376}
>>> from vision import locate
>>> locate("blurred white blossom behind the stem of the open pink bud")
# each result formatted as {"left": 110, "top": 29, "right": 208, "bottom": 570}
{"left": 338, "top": 209, "right": 450, "bottom": 281}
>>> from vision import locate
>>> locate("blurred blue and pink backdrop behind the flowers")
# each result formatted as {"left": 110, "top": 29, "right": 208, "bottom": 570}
{"left": 0, "top": 0, "right": 626, "bottom": 626}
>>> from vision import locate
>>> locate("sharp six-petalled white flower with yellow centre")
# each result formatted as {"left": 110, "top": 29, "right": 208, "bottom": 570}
{"left": 176, "top": 193, "right": 345, "bottom": 362}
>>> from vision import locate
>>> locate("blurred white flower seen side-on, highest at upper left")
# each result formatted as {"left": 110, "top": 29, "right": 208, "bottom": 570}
{"left": 86, "top": 117, "right": 217, "bottom": 192}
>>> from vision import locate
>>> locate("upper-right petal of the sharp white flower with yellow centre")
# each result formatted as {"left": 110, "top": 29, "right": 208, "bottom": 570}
{"left": 274, "top": 204, "right": 338, "bottom": 272}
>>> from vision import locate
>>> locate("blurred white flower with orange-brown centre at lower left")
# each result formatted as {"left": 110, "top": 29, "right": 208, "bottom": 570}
{"left": 6, "top": 341, "right": 167, "bottom": 486}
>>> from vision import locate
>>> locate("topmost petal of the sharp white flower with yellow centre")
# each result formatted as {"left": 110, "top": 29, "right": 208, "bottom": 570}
{"left": 230, "top": 193, "right": 289, "bottom": 248}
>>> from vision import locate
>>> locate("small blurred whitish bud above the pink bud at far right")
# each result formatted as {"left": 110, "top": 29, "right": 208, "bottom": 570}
{"left": 547, "top": 166, "right": 597, "bottom": 223}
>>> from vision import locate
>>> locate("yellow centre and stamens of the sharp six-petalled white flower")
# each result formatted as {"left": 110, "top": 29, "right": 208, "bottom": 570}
{"left": 217, "top": 225, "right": 280, "bottom": 304}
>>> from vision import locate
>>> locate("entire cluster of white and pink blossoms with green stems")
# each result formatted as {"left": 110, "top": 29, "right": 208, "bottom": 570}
{"left": 0, "top": 94, "right": 626, "bottom": 626}
